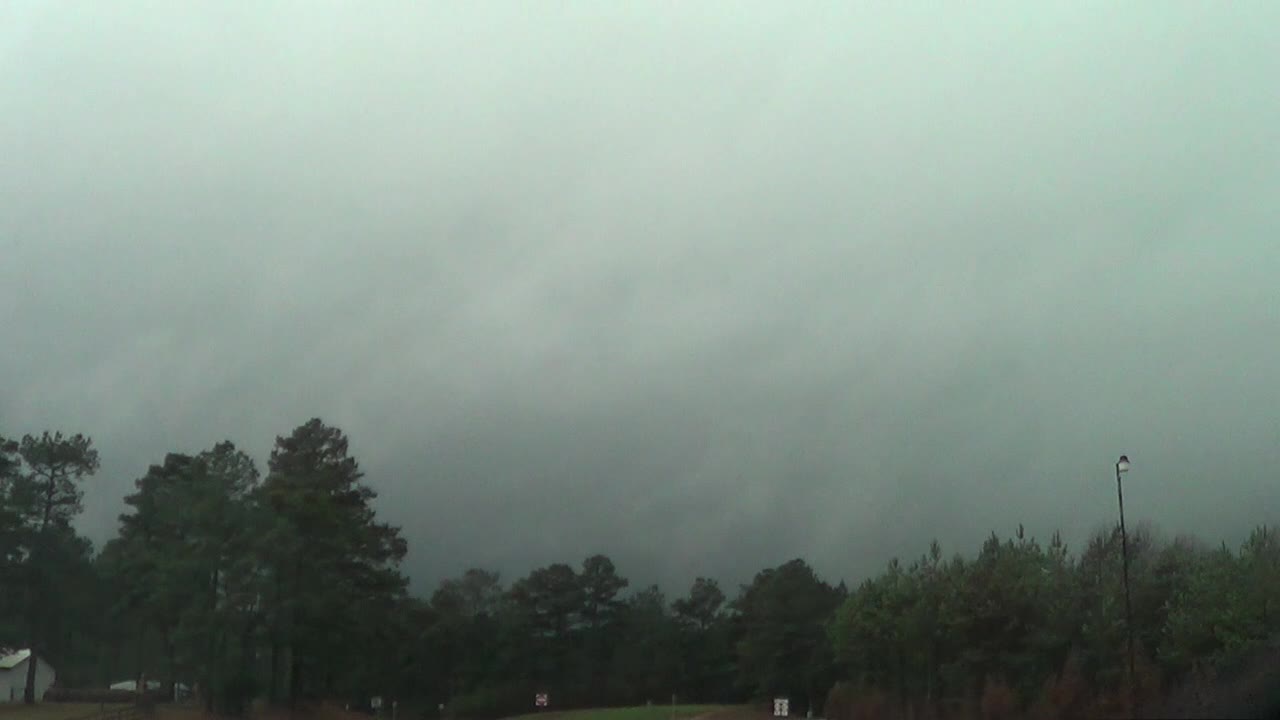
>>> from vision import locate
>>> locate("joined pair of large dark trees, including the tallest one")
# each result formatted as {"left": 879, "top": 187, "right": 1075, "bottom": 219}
{"left": 100, "top": 420, "right": 412, "bottom": 712}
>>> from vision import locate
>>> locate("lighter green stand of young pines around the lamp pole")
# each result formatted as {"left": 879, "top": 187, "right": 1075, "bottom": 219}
{"left": 829, "top": 520, "right": 1280, "bottom": 717}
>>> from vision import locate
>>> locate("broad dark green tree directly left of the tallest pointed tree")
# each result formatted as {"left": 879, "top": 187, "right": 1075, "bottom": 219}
{"left": 101, "top": 442, "right": 262, "bottom": 711}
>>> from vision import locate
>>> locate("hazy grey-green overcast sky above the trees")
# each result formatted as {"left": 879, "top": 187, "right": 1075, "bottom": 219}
{"left": 0, "top": 0, "right": 1280, "bottom": 592}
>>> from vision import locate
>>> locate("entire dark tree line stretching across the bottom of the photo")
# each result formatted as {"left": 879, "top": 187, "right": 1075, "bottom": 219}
{"left": 0, "top": 419, "right": 1280, "bottom": 719}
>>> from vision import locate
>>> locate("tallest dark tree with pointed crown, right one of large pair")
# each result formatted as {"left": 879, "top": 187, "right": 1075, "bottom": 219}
{"left": 255, "top": 419, "right": 407, "bottom": 702}
